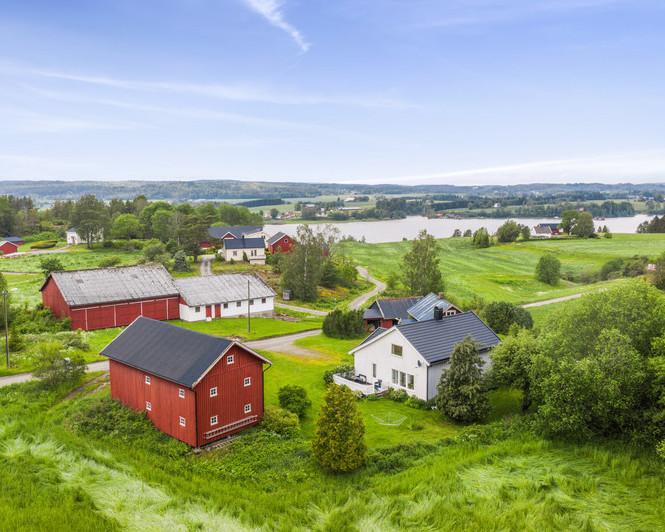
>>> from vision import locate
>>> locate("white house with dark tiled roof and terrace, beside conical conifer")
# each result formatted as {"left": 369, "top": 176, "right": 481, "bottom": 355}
{"left": 348, "top": 311, "right": 499, "bottom": 401}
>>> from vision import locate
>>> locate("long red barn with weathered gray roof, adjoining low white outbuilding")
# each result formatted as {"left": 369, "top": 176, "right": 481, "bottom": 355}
{"left": 41, "top": 265, "right": 180, "bottom": 331}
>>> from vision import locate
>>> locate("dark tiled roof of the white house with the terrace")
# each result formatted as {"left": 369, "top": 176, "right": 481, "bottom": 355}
{"left": 396, "top": 312, "right": 500, "bottom": 364}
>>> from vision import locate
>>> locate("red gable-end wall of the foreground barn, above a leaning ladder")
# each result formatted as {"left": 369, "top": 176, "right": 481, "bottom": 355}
{"left": 194, "top": 345, "right": 263, "bottom": 446}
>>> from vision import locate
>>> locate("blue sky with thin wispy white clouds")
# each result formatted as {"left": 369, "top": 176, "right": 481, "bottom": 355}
{"left": 0, "top": 0, "right": 665, "bottom": 184}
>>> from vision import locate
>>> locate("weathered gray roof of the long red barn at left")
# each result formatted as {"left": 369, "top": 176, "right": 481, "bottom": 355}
{"left": 41, "top": 265, "right": 178, "bottom": 306}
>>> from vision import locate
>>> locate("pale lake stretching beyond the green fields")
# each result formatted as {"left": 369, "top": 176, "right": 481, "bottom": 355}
{"left": 265, "top": 214, "right": 652, "bottom": 244}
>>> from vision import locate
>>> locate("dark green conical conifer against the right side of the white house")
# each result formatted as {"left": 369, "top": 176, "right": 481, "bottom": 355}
{"left": 436, "top": 337, "right": 489, "bottom": 423}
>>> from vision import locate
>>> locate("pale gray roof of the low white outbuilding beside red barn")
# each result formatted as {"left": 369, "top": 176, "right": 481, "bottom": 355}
{"left": 175, "top": 273, "right": 275, "bottom": 306}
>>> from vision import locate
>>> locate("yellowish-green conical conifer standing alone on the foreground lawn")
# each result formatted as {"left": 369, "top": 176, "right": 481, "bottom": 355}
{"left": 312, "top": 384, "right": 367, "bottom": 473}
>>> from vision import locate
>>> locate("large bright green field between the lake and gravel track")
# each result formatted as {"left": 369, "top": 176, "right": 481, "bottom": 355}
{"left": 343, "top": 234, "right": 665, "bottom": 303}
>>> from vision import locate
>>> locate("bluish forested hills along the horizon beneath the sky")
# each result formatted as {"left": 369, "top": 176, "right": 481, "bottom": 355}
{"left": 0, "top": 180, "right": 665, "bottom": 201}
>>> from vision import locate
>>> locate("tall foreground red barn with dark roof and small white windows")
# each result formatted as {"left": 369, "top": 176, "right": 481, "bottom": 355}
{"left": 102, "top": 318, "right": 270, "bottom": 447}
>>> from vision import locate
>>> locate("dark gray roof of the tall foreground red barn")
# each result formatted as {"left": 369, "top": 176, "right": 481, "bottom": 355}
{"left": 102, "top": 317, "right": 270, "bottom": 388}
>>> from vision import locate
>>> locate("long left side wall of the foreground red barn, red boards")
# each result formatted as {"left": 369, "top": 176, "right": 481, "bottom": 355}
{"left": 109, "top": 360, "right": 196, "bottom": 447}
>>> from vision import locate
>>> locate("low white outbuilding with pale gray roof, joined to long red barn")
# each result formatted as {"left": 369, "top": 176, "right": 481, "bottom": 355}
{"left": 174, "top": 274, "right": 275, "bottom": 321}
